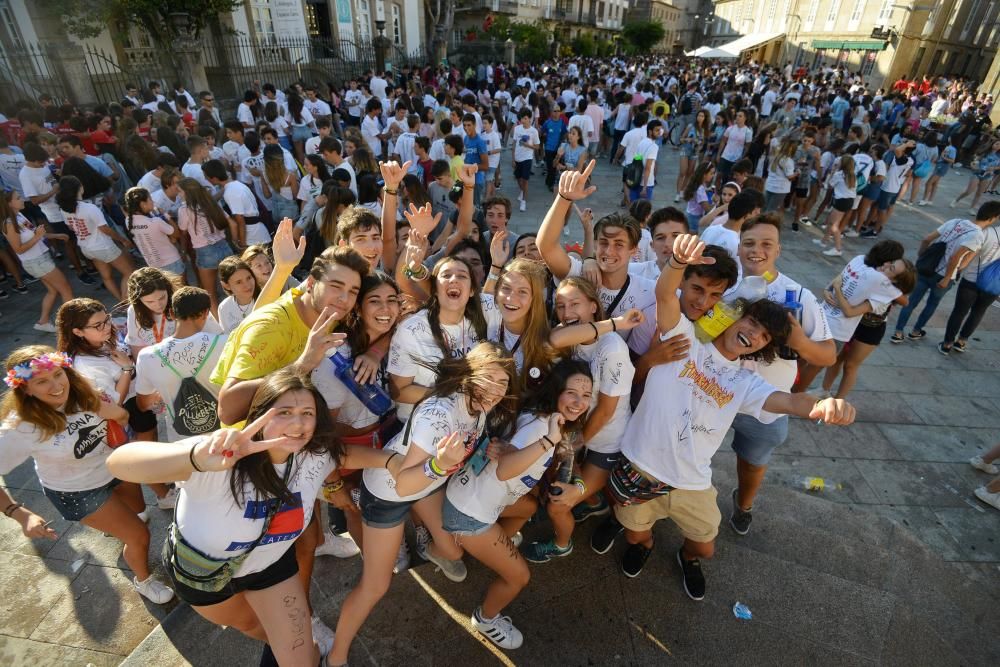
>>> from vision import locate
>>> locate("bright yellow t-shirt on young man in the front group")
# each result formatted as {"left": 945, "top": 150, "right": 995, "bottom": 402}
{"left": 211, "top": 288, "right": 309, "bottom": 385}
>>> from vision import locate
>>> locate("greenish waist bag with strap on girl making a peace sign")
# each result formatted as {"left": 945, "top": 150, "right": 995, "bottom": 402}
{"left": 161, "top": 458, "right": 294, "bottom": 593}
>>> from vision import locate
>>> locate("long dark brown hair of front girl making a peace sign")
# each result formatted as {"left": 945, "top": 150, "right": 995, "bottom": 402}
{"left": 229, "top": 368, "right": 344, "bottom": 505}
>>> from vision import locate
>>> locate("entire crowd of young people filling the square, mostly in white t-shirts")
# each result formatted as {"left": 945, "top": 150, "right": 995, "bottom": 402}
{"left": 0, "top": 58, "right": 1000, "bottom": 666}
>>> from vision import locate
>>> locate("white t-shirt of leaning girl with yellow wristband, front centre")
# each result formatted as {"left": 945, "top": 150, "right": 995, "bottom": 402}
{"left": 363, "top": 394, "right": 486, "bottom": 502}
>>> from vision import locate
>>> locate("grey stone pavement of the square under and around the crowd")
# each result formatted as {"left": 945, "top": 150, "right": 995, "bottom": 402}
{"left": 0, "top": 142, "right": 1000, "bottom": 667}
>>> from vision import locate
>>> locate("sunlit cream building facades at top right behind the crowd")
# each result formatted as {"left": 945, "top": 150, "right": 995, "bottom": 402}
{"left": 704, "top": 0, "right": 1000, "bottom": 86}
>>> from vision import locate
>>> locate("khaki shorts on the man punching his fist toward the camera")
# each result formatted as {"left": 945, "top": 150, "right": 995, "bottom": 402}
{"left": 615, "top": 486, "right": 722, "bottom": 542}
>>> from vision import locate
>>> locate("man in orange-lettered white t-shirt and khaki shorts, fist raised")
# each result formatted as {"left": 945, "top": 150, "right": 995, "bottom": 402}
{"left": 588, "top": 231, "right": 854, "bottom": 600}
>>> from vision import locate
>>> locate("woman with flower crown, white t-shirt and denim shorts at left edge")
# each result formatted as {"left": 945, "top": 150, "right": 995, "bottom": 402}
{"left": 0, "top": 345, "right": 174, "bottom": 604}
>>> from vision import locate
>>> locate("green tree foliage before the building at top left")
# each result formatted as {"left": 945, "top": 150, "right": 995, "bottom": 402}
{"left": 54, "top": 0, "right": 244, "bottom": 46}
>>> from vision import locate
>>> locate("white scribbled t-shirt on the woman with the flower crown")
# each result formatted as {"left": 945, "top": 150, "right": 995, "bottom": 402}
{"left": 0, "top": 412, "right": 112, "bottom": 491}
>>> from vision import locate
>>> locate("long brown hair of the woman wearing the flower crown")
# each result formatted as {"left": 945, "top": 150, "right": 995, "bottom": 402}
{"left": 0, "top": 345, "right": 101, "bottom": 440}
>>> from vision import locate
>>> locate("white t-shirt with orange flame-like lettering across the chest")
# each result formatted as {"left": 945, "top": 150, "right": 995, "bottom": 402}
{"left": 622, "top": 316, "right": 775, "bottom": 490}
